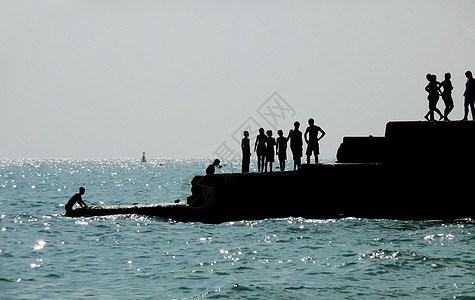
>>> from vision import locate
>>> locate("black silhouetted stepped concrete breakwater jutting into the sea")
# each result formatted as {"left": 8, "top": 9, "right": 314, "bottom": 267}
{"left": 72, "top": 121, "right": 475, "bottom": 223}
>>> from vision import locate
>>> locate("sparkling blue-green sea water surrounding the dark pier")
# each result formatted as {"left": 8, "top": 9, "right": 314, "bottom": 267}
{"left": 0, "top": 159, "right": 475, "bottom": 299}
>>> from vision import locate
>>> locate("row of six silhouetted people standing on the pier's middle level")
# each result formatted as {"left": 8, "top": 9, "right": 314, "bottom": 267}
{"left": 241, "top": 118, "right": 325, "bottom": 173}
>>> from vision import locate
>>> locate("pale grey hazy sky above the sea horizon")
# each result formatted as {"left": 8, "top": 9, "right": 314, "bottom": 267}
{"left": 0, "top": 0, "right": 475, "bottom": 159}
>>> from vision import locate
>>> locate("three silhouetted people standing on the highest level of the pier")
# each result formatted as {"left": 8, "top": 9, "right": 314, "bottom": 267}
{"left": 424, "top": 71, "right": 475, "bottom": 121}
